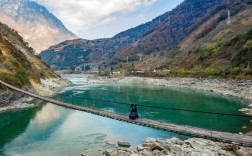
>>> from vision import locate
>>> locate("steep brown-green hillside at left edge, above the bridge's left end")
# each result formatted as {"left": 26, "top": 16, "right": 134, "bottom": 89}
{"left": 0, "top": 23, "right": 57, "bottom": 90}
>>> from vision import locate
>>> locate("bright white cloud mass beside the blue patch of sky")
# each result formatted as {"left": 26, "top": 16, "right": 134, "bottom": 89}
{"left": 40, "top": 0, "right": 157, "bottom": 37}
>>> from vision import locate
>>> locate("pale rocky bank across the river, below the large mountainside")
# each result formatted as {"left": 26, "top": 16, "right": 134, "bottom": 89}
{"left": 88, "top": 75, "right": 252, "bottom": 102}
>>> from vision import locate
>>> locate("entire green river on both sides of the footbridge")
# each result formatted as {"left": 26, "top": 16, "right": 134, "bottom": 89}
{"left": 0, "top": 75, "right": 251, "bottom": 156}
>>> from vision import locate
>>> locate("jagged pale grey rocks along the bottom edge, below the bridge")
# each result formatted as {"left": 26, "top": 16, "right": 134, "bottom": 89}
{"left": 102, "top": 138, "right": 252, "bottom": 156}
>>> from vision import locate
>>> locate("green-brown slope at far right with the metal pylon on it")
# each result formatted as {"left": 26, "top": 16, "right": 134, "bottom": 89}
{"left": 167, "top": 7, "right": 252, "bottom": 69}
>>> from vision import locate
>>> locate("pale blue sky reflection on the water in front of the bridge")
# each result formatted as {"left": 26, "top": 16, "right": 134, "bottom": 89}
{"left": 4, "top": 104, "right": 182, "bottom": 156}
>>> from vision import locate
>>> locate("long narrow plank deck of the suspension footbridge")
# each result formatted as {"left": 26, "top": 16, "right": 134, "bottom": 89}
{"left": 0, "top": 80, "right": 252, "bottom": 147}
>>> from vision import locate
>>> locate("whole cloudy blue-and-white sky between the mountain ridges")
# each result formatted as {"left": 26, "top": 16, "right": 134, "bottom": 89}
{"left": 43, "top": 0, "right": 183, "bottom": 39}
